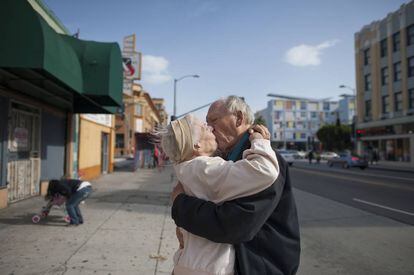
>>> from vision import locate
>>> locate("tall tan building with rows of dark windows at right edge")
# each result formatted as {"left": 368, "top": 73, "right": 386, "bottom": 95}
{"left": 355, "top": 1, "right": 414, "bottom": 166}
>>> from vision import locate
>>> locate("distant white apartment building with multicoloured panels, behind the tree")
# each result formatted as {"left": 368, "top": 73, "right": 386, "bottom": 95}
{"left": 256, "top": 95, "right": 349, "bottom": 150}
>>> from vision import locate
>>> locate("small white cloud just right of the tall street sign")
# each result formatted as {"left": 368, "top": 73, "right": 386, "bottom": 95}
{"left": 142, "top": 55, "right": 172, "bottom": 84}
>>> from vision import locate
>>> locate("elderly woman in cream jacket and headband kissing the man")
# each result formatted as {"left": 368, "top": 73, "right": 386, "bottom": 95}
{"left": 160, "top": 116, "right": 279, "bottom": 275}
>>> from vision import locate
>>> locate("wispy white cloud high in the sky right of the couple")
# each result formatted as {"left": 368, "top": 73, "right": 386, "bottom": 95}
{"left": 285, "top": 39, "right": 339, "bottom": 67}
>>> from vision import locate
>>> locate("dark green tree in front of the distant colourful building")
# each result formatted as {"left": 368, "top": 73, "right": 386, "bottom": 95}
{"left": 316, "top": 125, "right": 352, "bottom": 151}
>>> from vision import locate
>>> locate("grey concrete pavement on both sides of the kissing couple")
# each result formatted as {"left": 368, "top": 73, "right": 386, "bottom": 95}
{"left": 0, "top": 165, "right": 414, "bottom": 275}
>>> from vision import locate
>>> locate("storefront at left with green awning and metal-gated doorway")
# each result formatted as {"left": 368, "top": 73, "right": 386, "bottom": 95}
{"left": 0, "top": 0, "right": 122, "bottom": 208}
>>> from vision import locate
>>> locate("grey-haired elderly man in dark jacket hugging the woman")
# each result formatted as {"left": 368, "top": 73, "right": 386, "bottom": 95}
{"left": 172, "top": 96, "right": 300, "bottom": 275}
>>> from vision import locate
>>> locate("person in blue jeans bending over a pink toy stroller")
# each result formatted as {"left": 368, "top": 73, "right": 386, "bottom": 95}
{"left": 46, "top": 179, "right": 92, "bottom": 226}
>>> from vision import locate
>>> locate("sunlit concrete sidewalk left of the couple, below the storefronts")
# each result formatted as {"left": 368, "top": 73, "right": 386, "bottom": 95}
{"left": 0, "top": 165, "right": 178, "bottom": 274}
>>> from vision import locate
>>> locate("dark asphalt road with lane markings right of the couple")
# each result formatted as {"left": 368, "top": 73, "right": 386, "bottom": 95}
{"left": 290, "top": 162, "right": 414, "bottom": 225}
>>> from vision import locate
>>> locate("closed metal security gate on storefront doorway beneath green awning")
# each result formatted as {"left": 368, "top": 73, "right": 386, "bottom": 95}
{"left": 7, "top": 102, "right": 40, "bottom": 202}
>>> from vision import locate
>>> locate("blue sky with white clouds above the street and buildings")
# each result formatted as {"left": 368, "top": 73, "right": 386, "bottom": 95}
{"left": 43, "top": 0, "right": 409, "bottom": 121}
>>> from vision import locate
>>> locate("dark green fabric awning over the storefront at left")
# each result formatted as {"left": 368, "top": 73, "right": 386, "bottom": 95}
{"left": 0, "top": 0, "right": 122, "bottom": 113}
